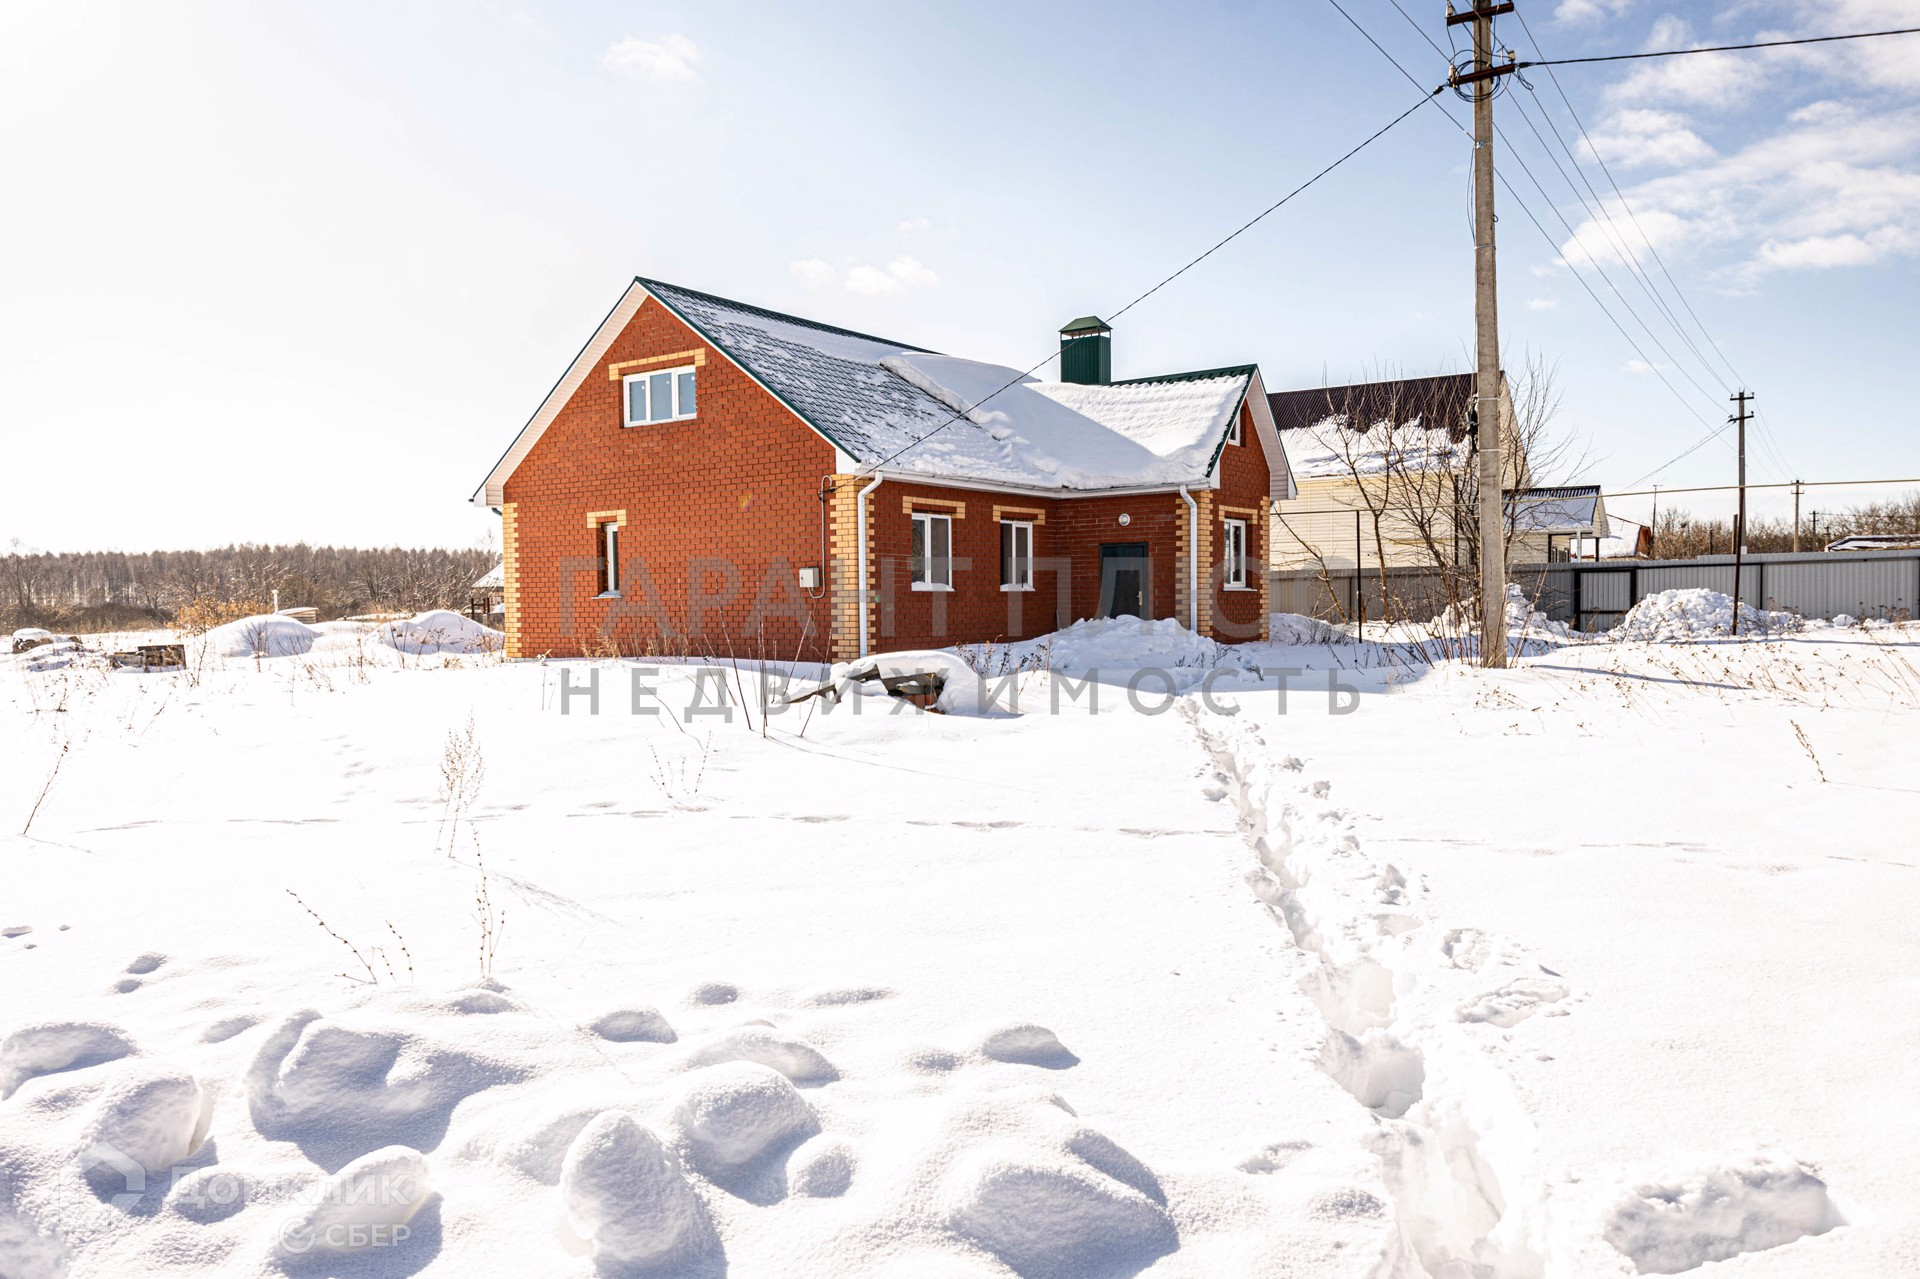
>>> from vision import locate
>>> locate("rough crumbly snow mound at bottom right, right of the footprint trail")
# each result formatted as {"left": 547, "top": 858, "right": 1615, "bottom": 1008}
{"left": 1605, "top": 1152, "right": 1845, "bottom": 1275}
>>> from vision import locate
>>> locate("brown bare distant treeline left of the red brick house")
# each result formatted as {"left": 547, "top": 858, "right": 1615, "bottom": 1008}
{"left": 0, "top": 543, "right": 499, "bottom": 632}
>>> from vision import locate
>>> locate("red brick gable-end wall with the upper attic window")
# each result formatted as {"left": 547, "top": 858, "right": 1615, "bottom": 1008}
{"left": 501, "top": 300, "right": 833, "bottom": 659}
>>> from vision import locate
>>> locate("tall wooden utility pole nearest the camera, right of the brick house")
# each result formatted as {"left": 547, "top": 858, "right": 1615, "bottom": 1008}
{"left": 1446, "top": 0, "right": 1515, "bottom": 666}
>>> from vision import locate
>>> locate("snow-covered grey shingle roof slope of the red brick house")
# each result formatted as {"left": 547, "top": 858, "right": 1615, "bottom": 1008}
{"left": 639, "top": 280, "right": 1254, "bottom": 490}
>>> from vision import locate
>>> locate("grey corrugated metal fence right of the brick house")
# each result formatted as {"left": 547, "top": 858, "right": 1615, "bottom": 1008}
{"left": 1269, "top": 551, "right": 1920, "bottom": 630}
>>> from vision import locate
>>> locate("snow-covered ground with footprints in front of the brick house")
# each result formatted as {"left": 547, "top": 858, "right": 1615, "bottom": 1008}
{"left": 0, "top": 609, "right": 1920, "bottom": 1279}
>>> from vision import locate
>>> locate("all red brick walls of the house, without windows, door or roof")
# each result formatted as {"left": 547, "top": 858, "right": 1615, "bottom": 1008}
{"left": 501, "top": 300, "right": 1267, "bottom": 661}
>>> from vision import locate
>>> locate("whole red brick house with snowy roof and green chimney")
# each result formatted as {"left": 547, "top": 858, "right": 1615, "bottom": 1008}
{"left": 472, "top": 278, "right": 1292, "bottom": 661}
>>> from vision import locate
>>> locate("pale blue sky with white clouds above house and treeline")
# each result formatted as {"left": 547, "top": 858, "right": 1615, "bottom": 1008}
{"left": 0, "top": 0, "right": 1920, "bottom": 549}
